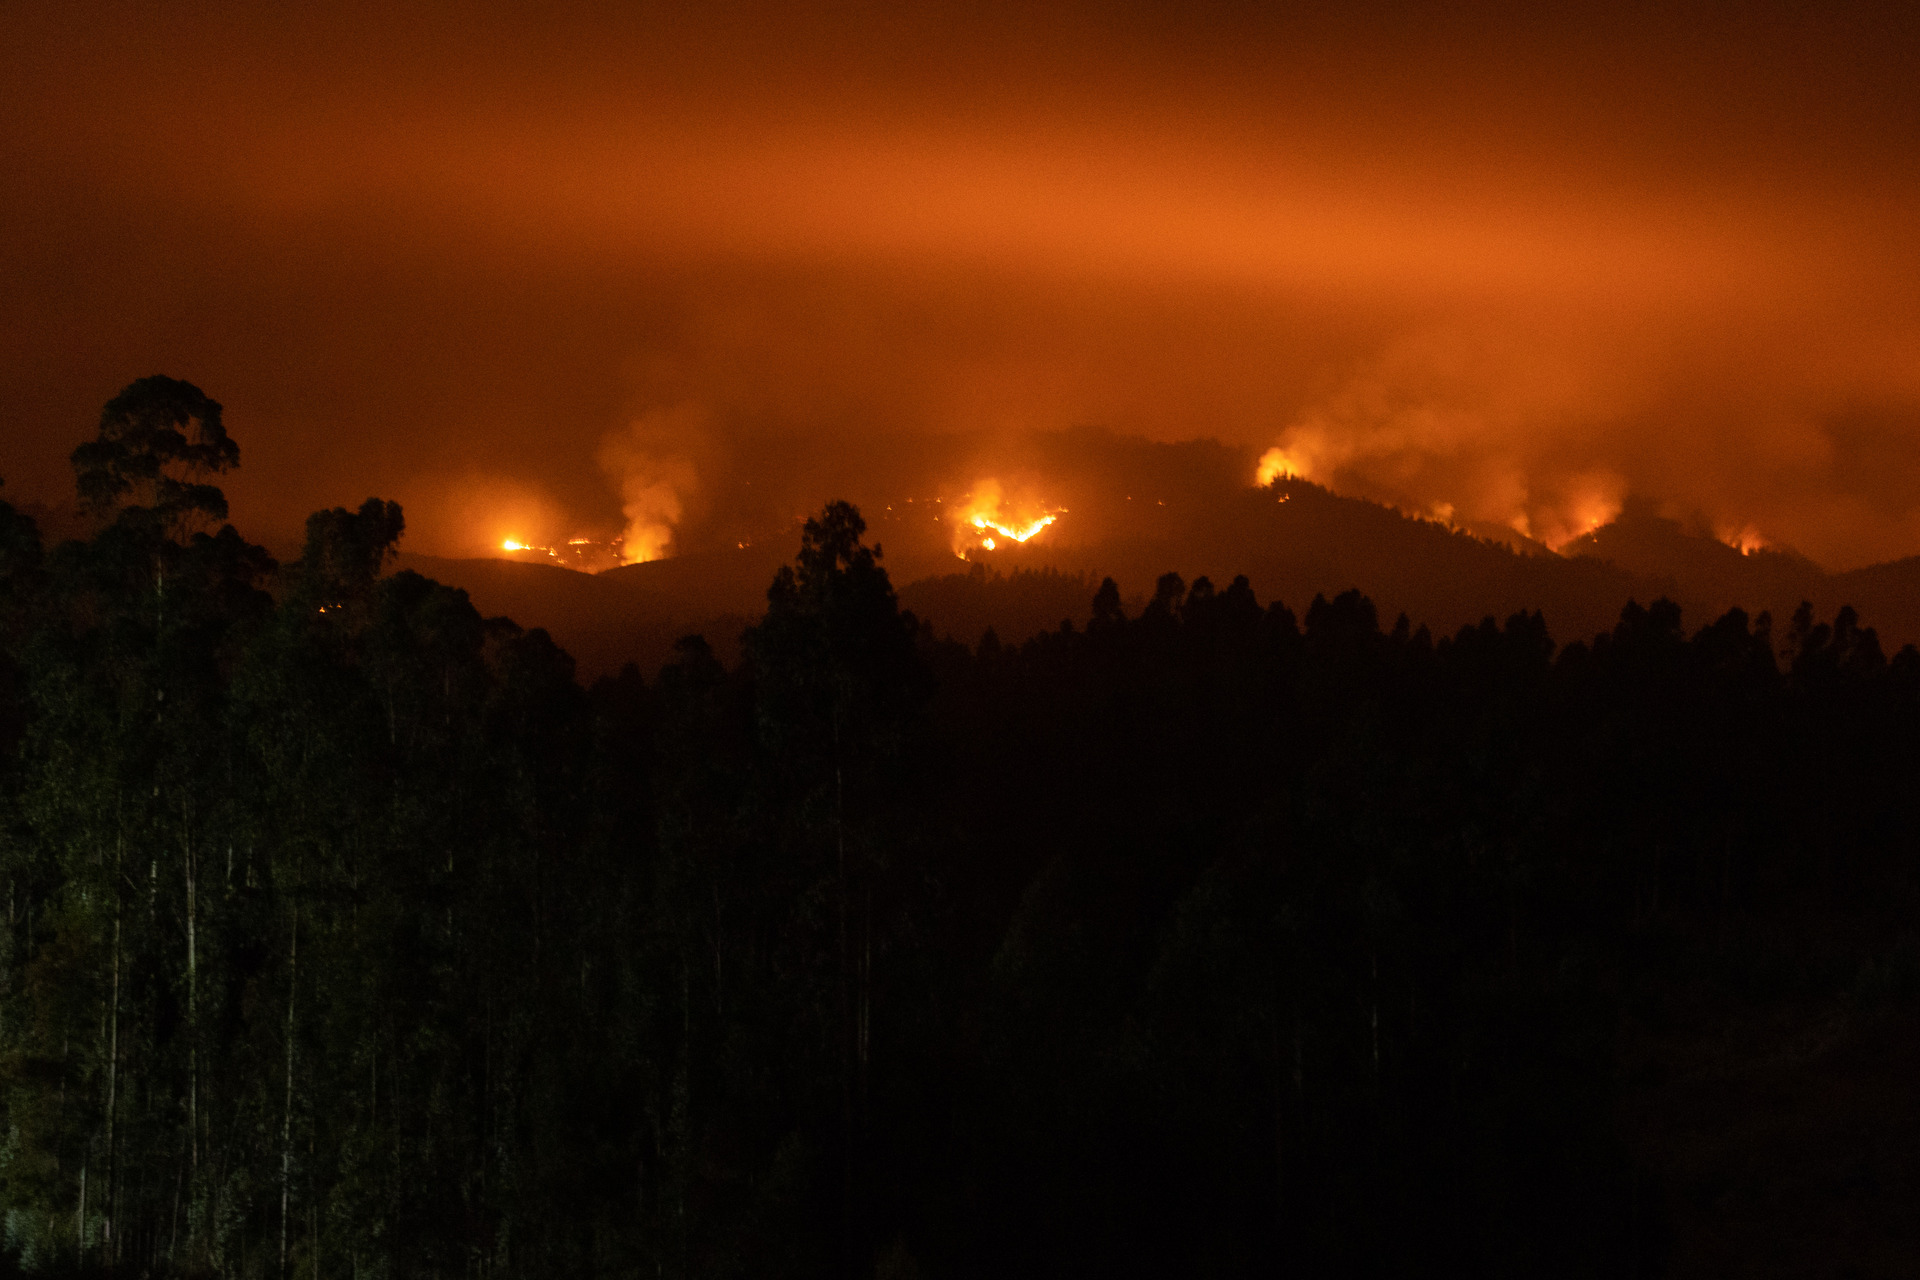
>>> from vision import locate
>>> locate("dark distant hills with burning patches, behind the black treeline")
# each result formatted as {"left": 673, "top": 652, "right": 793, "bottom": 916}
{"left": 399, "top": 474, "right": 1920, "bottom": 677}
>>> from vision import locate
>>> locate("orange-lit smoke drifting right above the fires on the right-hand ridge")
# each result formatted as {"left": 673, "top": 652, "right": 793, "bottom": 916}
{"left": 1260, "top": 315, "right": 1920, "bottom": 566}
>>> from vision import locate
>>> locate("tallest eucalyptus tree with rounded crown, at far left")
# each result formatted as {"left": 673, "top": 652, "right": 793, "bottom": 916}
{"left": 8, "top": 378, "right": 275, "bottom": 1265}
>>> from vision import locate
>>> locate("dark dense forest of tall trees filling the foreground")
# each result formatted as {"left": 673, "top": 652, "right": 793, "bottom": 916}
{"left": 0, "top": 378, "right": 1920, "bottom": 1280}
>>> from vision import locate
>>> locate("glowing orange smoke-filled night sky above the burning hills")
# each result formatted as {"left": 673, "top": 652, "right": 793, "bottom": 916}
{"left": 0, "top": 0, "right": 1920, "bottom": 568}
